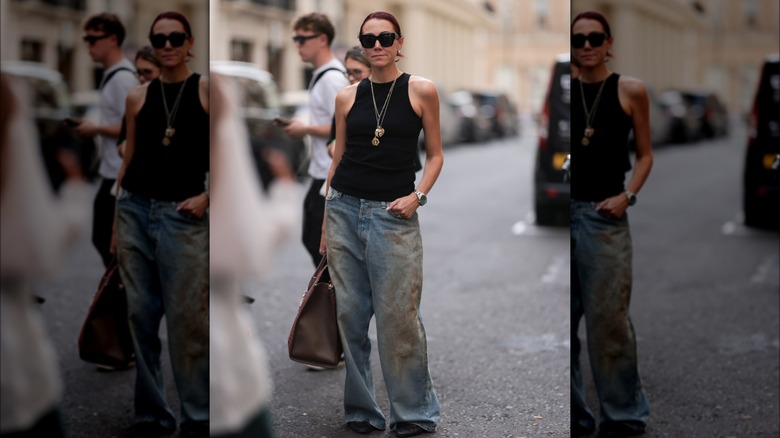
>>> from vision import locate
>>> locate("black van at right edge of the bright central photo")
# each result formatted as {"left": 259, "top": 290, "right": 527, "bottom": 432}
{"left": 534, "top": 53, "right": 571, "bottom": 225}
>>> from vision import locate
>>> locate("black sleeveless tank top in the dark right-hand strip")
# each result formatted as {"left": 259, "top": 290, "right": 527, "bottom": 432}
{"left": 570, "top": 73, "right": 633, "bottom": 202}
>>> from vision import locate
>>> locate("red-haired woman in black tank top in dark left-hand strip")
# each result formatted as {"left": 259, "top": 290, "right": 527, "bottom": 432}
{"left": 115, "top": 12, "right": 209, "bottom": 436}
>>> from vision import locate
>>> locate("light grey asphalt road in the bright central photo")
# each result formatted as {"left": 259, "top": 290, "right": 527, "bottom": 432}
{"left": 256, "top": 120, "right": 569, "bottom": 438}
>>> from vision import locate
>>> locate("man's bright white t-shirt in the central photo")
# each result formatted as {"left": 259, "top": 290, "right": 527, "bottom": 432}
{"left": 309, "top": 58, "right": 349, "bottom": 179}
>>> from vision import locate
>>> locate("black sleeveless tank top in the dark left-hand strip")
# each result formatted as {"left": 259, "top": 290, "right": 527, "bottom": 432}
{"left": 122, "top": 73, "right": 209, "bottom": 202}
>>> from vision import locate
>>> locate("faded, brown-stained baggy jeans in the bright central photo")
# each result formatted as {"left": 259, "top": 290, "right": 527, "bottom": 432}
{"left": 325, "top": 188, "right": 440, "bottom": 431}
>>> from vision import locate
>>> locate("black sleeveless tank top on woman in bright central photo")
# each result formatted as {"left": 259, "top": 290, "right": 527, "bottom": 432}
{"left": 331, "top": 73, "right": 422, "bottom": 202}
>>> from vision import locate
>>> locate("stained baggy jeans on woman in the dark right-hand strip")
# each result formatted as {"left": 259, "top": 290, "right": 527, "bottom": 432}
{"left": 571, "top": 200, "right": 650, "bottom": 431}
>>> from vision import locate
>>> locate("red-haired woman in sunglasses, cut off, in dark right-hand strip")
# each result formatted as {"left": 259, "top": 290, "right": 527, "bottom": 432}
{"left": 571, "top": 12, "right": 653, "bottom": 436}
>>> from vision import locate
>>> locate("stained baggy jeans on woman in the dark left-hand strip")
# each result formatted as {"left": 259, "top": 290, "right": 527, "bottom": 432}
{"left": 117, "top": 190, "right": 209, "bottom": 428}
